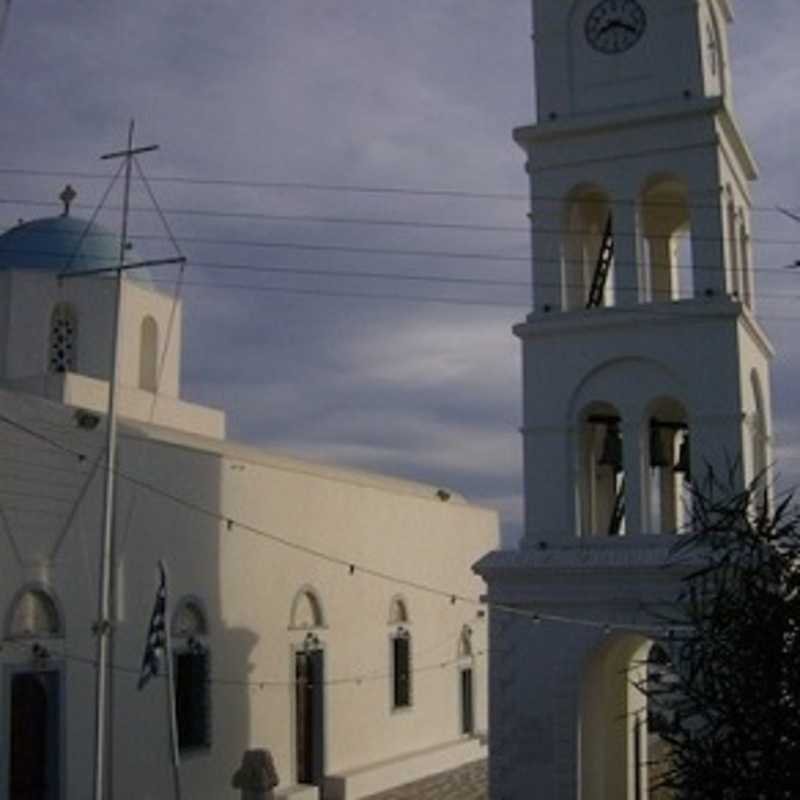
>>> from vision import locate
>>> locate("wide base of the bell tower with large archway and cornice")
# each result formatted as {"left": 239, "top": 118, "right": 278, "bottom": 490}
{"left": 475, "top": 536, "right": 688, "bottom": 800}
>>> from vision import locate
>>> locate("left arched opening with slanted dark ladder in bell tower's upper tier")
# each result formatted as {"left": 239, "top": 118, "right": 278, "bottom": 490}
{"left": 561, "top": 184, "right": 614, "bottom": 310}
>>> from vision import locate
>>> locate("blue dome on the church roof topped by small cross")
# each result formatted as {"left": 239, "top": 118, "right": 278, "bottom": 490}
{"left": 0, "top": 216, "right": 153, "bottom": 288}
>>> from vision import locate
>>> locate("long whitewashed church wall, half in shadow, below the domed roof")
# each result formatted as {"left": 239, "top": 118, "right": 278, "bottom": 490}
{"left": 0, "top": 384, "right": 499, "bottom": 800}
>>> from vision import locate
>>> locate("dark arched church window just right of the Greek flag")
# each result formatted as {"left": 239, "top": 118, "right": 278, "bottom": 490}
{"left": 172, "top": 597, "right": 211, "bottom": 751}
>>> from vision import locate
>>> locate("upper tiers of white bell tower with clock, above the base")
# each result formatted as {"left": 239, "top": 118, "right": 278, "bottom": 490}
{"left": 514, "top": 0, "right": 772, "bottom": 543}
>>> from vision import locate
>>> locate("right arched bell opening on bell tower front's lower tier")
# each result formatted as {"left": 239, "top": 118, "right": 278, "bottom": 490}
{"left": 647, "top": 398, "right": 691, "bottom": 533}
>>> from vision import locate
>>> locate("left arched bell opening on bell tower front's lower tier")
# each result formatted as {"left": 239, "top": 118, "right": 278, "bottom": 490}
{"left": 578, "top": 403, "right": 625, "bottom": 536}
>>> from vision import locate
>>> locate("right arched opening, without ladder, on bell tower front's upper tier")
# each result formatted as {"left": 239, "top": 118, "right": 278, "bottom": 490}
{"left": 640, "top": 174, "right": 694, "bottom": 303}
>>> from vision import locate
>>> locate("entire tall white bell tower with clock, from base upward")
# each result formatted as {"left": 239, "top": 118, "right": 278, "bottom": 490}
{"left": 476, "top": 0, "right": 772, "bottom": 800}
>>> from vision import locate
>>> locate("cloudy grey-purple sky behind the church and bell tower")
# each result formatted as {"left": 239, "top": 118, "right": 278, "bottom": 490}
{"left": 0, "top": 0, "right": 800, "bottom": 538}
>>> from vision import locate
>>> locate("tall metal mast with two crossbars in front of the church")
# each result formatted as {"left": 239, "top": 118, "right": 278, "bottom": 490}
{"left": 59, "top": 120, "right": 186, "bottom": 800}
